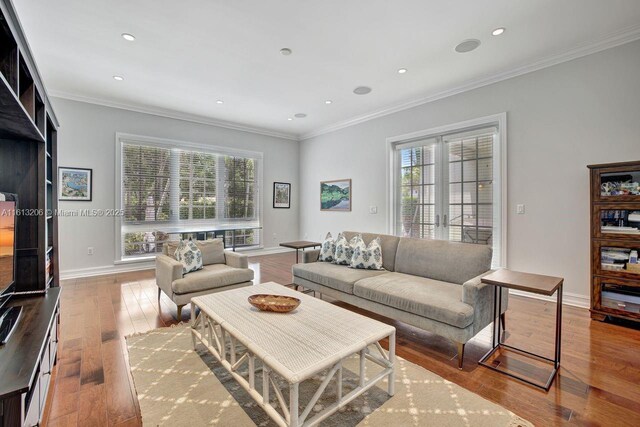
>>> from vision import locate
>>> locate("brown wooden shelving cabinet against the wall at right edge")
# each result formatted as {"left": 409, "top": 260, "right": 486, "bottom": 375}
{"left": 588, "top": 161, "right": 640, "bottom": 322}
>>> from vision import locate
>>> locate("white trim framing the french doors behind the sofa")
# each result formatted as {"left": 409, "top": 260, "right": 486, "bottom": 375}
{"left": 386, "top": 112, "right": 508, "bottom": 268}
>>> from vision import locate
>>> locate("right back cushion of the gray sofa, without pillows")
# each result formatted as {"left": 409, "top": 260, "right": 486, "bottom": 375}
{"left": 392, "top": 237, "right": 492, "bottom": 285}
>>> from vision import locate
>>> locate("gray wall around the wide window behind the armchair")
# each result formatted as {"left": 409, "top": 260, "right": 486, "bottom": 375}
{"left": 53, "top": 98, "right": 299, "bottom": 276}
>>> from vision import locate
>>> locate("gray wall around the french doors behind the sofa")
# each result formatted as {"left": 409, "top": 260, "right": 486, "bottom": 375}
{"left": 300, "top": 42, "right": 640, "bottom": 304}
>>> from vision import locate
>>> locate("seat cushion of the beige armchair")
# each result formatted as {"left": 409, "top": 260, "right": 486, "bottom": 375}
{"left": 171, "top": 264, "right": 253, "bottom": 294}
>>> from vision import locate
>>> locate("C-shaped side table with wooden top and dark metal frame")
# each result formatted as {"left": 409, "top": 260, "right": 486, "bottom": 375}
{"left": 478, "top": 269, "right": 564, "bottom": 391}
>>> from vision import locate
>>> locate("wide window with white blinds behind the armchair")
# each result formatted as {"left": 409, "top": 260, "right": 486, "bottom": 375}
{"left": 119, "top": 140, "right": 261, "bottom": 259}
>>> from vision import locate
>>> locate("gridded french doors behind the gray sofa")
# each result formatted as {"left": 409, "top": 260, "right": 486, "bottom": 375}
{"left": 394, "top": 126, "right": 501, "bottom": 264}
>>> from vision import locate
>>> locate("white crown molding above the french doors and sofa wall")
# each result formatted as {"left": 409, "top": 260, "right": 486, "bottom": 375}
{"left": 300, "top": 26, "right": 640, "bottom": 141}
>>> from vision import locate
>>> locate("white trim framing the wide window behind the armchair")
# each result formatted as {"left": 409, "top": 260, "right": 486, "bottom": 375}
{"left": 113, "top": 132, "right": 264, "bottom": 265}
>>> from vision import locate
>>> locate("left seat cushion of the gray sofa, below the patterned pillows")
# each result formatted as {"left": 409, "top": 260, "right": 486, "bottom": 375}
{"left": 293, "top": 262, "right": 385, "bottom": 294}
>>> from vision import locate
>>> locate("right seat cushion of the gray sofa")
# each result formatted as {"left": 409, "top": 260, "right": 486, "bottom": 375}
{"left": 353, "top": 273, "right": 473, "bottom": 328}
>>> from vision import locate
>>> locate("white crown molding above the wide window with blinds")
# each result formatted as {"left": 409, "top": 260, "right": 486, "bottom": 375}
{"left": 49, "top": 90, "right": 299, "bottom": 141}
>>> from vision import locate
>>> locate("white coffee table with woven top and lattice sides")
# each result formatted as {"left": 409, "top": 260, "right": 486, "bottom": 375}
{"left": 191, "top": 282, "right": 396, "bottom": 427}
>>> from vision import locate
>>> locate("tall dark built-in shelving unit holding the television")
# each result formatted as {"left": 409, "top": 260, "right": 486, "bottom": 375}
{"left": 0, "top": 0, "right": 60, "bottom": 427}
